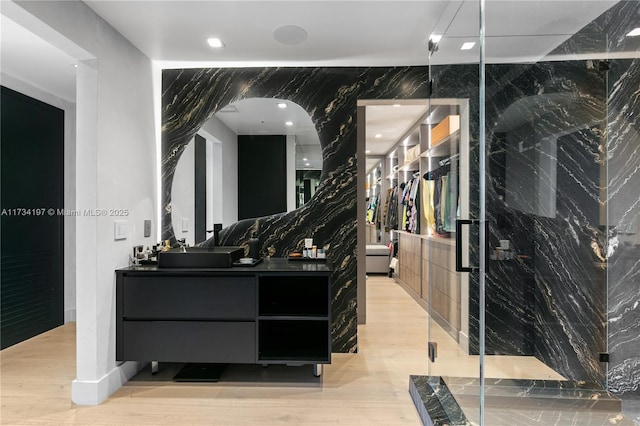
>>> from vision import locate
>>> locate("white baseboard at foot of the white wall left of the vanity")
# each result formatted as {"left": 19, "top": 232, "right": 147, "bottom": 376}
{"left": 71, "top": 361, "right": 141, "bottom": 405}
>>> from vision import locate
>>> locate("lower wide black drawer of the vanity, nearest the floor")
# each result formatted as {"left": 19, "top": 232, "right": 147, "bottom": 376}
{"left": 116, "top": 321, "right": 256, "bottom": 364}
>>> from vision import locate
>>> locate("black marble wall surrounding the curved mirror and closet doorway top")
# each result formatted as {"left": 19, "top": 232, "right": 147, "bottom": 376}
{"left": 162, "top": 67, "right": 428, "bottom": 352}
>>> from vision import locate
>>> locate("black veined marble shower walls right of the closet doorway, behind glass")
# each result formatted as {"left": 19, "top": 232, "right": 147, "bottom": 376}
{"left": 435, "top": 53, "right": 640, "bottom": 392}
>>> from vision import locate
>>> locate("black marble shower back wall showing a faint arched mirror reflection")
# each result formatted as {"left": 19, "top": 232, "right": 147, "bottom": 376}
{"left": 462, "top": 61, "right": 606, "bottom": 385}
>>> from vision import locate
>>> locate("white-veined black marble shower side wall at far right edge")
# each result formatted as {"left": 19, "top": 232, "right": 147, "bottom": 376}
{"left": 607, "top": 59, "right": 640, "bottom": 395}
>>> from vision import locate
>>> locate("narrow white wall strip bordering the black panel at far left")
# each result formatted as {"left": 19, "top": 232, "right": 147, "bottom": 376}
{"left": 0, "top": 74, "right": 76, "bottom": 323}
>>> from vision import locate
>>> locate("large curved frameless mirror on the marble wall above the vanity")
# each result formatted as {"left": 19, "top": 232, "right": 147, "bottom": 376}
{"left": 171, "top": 98, "right": 322, "bottom": 245}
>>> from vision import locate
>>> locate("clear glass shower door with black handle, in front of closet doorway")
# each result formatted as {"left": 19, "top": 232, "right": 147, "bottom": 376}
{"left": 422, "top": 1, "right": 482, "bottom": 424}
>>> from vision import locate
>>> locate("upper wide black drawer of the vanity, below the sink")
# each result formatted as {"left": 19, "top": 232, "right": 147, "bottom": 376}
{"left": 122, "top": 276, "right": 256, "bottom": 320}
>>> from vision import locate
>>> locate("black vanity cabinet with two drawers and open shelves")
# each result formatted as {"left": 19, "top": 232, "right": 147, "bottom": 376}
{"left": 116, "top": 259, "right": 331, "bottom": 367}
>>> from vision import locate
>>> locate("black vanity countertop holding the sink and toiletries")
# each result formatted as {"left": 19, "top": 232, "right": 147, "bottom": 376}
{"left": 116, "top": 257, "right": 333, "bottom": 275}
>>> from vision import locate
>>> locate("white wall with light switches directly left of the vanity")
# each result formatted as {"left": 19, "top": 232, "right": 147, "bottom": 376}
{"left": 3, "top": 1, "right": 159, "bottom": 405}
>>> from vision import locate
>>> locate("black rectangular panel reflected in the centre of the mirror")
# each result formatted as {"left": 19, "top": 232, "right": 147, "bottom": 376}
{"left": 238, "top": 135, "right": 287, "bottom": 220}
